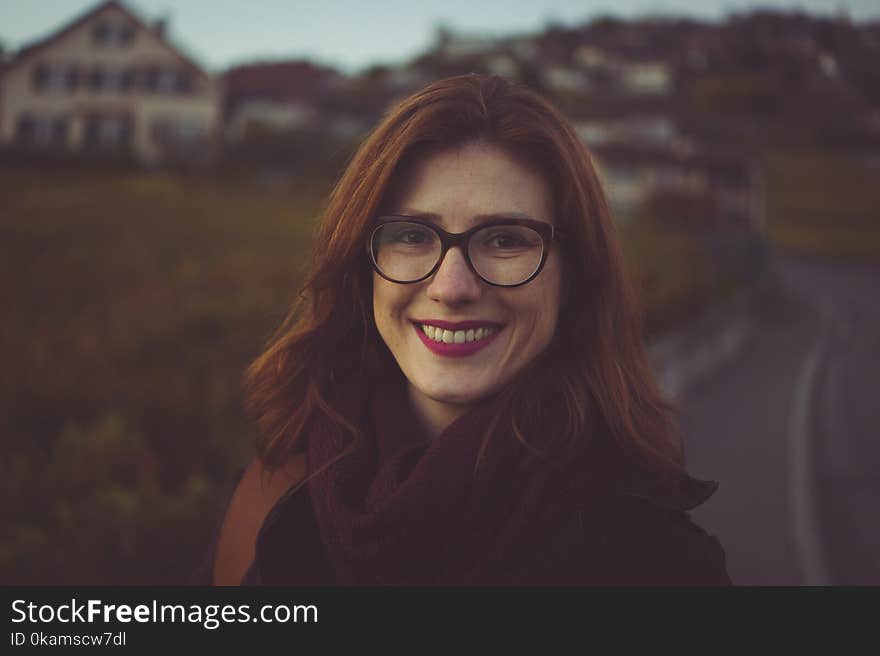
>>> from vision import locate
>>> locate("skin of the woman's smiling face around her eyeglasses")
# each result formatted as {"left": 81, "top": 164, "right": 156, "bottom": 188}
{"left": 373, "top": 143, "right": 561, "bottom": 428}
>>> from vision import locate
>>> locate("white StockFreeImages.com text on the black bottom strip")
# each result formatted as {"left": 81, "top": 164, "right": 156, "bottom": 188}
{"left": 12, "top": 599, "right": 318, "bottom": 630}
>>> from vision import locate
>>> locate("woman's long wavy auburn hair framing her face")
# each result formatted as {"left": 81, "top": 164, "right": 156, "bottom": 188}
{"left": 244, "top": 74, "right": 684, "bottom": 478}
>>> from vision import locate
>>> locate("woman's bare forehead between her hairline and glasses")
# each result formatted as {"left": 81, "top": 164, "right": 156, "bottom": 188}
{"left": 383, "top": 143, "right": 553, "bottom": 225}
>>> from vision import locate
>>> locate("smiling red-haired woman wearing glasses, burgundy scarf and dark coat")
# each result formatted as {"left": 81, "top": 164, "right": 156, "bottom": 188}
{"left": 198, "top": 75, "right": 730, "bottom": 585}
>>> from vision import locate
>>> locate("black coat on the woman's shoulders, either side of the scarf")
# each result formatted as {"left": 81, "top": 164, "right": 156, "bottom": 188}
{"left": 190, "top": 464, "right": 731, "bottom": 586}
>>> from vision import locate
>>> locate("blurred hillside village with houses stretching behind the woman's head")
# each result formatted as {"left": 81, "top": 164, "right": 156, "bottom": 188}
{"left": 0, "top": 0, "right": 880, "bottom": 227}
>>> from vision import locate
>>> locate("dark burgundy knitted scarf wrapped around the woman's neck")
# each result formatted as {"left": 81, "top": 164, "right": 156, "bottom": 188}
{"left": 308, "top": 368, "right": 711, "bottom": 585}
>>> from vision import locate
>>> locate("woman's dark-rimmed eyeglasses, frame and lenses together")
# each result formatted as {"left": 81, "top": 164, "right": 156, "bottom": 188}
{"left": 367, "top": 216, "right": 560, "bottom": 287}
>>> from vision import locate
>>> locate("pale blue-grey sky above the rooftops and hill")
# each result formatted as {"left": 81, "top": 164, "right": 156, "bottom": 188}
{"left": 0, "top": 0, "right": 880, "bottom": 73}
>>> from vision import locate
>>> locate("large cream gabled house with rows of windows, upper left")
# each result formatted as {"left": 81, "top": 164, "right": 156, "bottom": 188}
{"left": 0, "top": 0, "right": 222, "bottom": 162}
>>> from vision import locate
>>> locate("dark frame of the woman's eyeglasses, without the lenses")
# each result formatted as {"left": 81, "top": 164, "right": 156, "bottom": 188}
{"left": 367, "top": 214, "right": 562, "bottom": 287}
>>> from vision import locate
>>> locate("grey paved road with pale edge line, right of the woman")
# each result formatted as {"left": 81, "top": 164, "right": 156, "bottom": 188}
{"left": 679, "top": 250, "right": 880, "bottom": 585}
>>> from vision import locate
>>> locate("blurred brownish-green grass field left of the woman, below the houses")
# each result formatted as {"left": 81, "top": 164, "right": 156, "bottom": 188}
{"left": 0, "top": 172, "right": 321, "bottom": 583}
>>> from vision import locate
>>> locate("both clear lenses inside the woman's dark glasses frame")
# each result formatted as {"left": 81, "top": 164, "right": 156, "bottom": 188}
{"left": 372, "top": 221, "right": 544, "bottom": 285}
